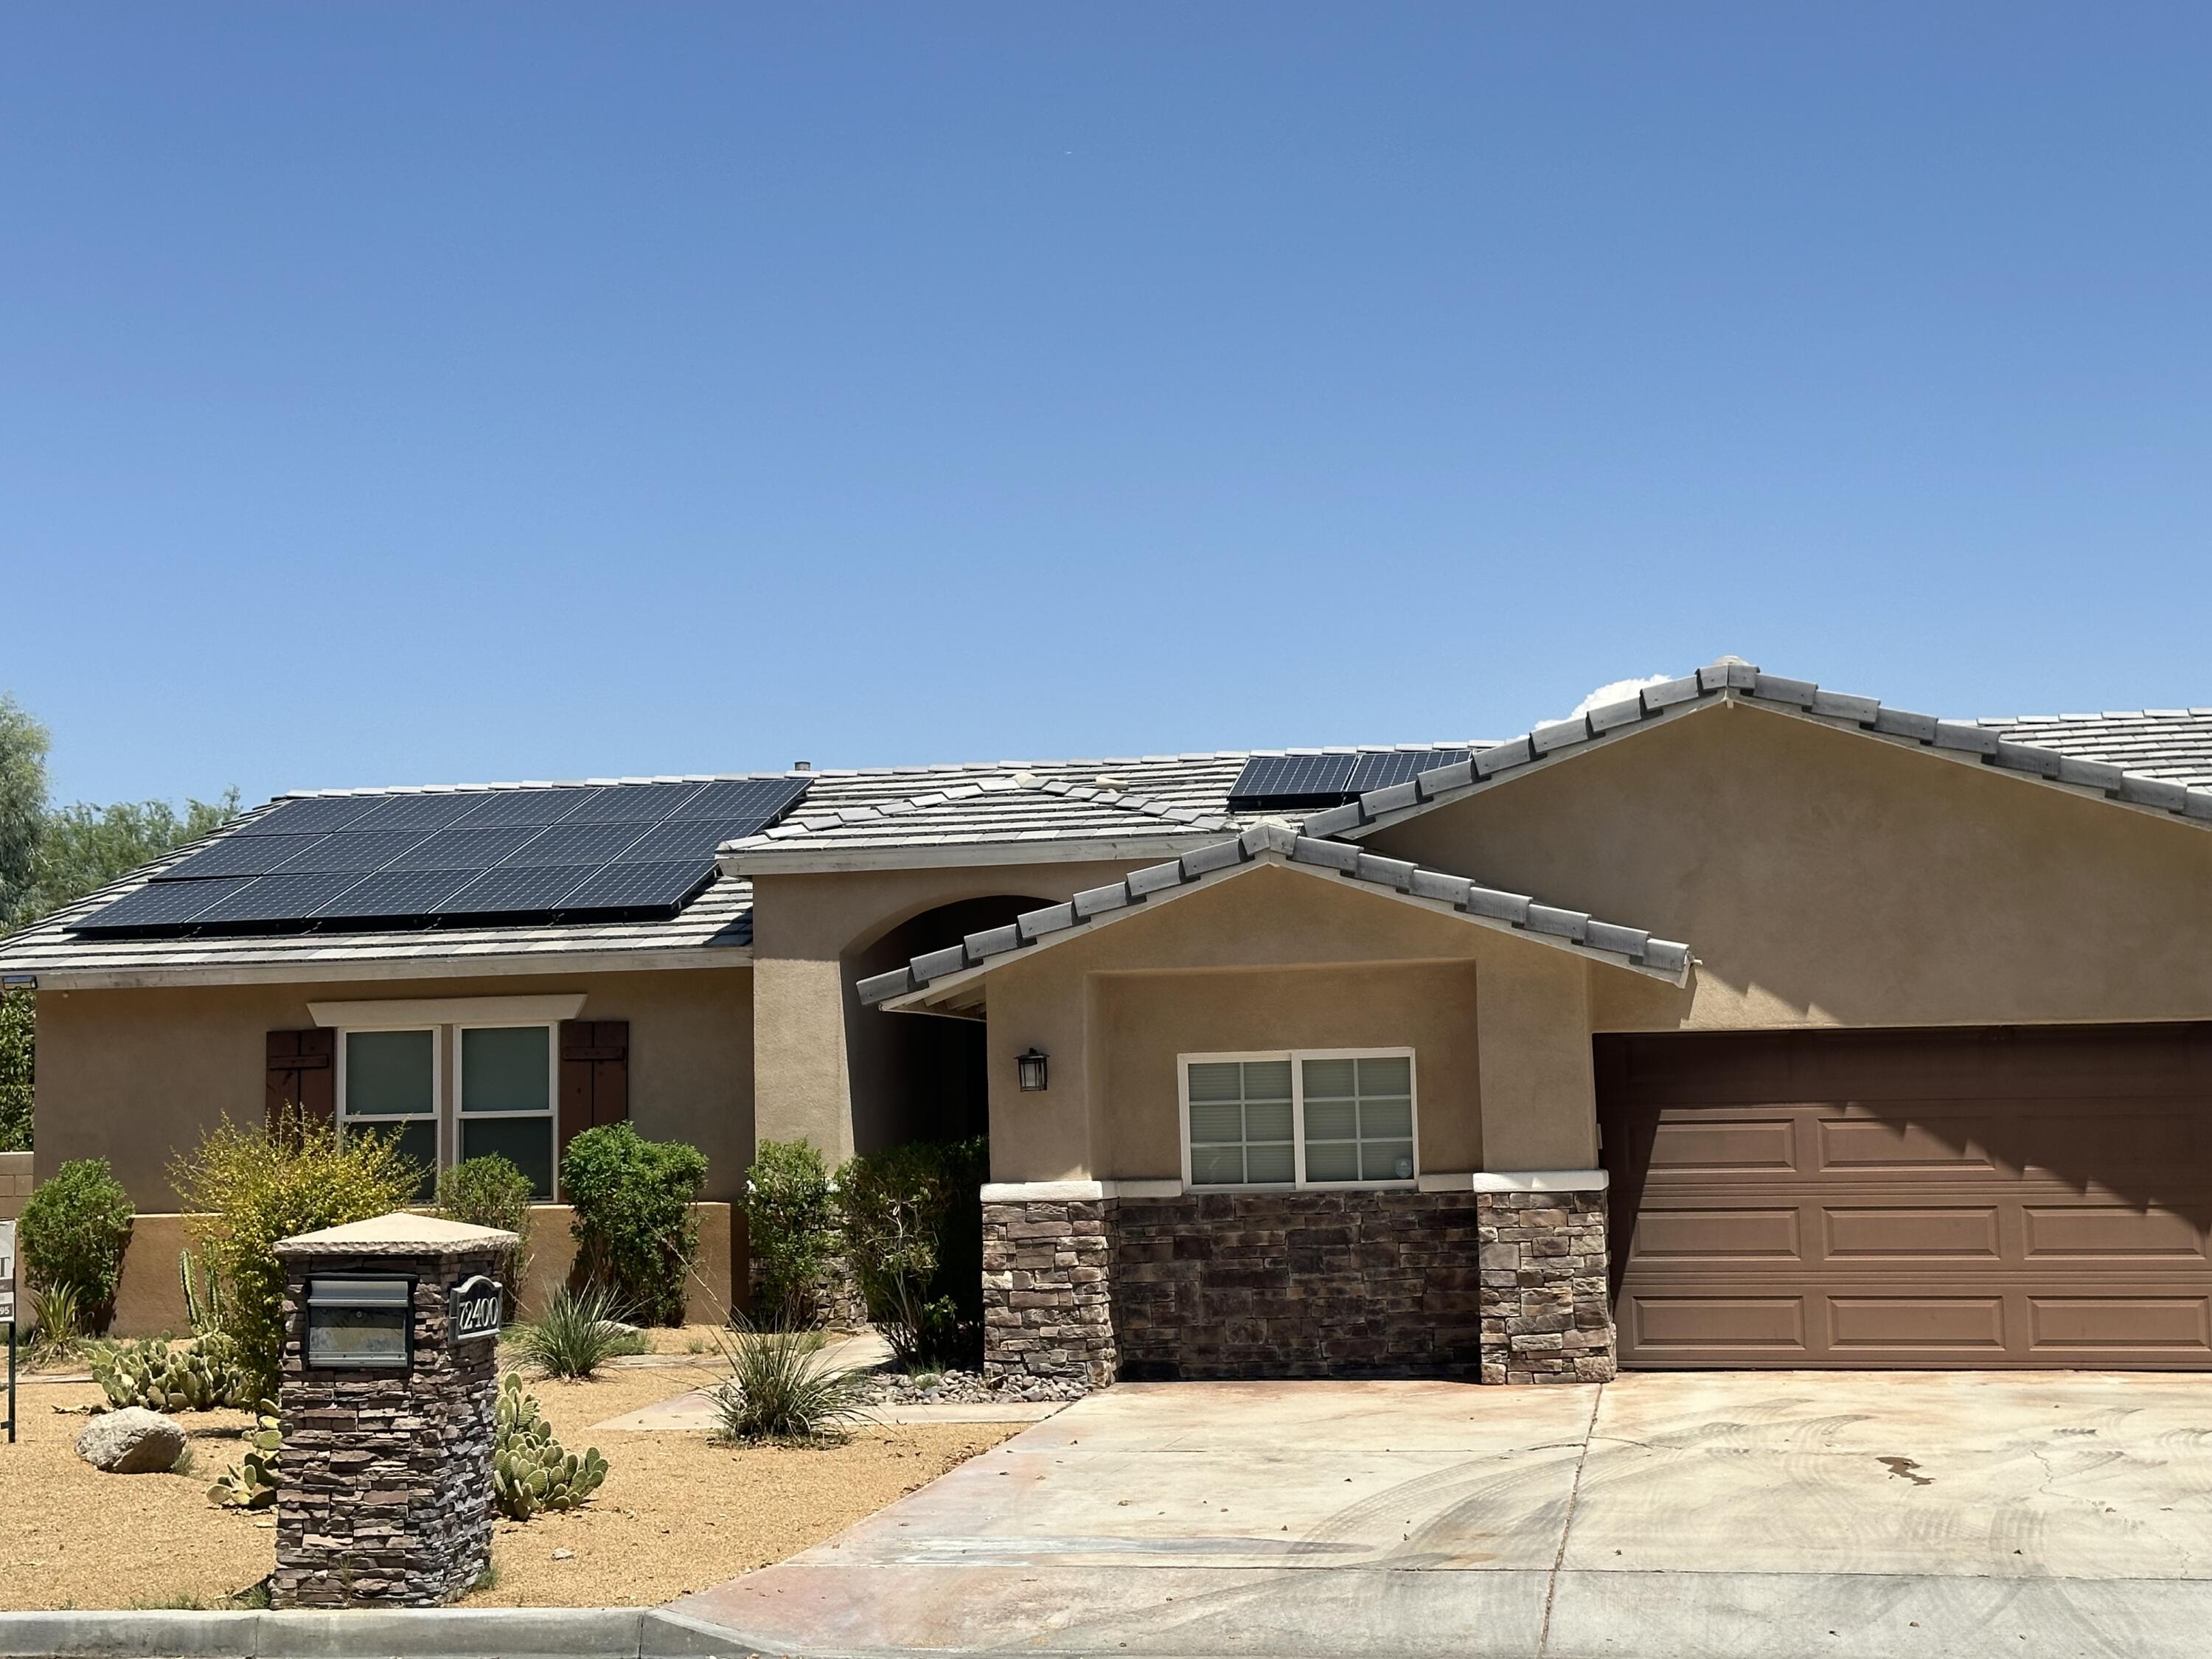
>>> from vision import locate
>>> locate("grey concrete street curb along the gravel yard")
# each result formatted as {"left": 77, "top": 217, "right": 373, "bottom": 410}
{"left": 0, "top": 1608, "right": 787, "bottom": 1659}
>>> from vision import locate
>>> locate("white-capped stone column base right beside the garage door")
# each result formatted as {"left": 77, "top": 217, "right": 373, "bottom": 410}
{"left": 1475, "top": 1170, "right": 1617, "bottom": 1382}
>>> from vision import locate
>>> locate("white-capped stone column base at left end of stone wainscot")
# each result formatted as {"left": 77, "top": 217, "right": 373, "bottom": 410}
{"left": 982, "top": 1181, "right": 1119, "bottom": 1389}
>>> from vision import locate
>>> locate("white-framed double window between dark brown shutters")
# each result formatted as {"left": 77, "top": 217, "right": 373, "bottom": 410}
{"left": 336, "top": 1022, "right": 560, "bottom": 1199}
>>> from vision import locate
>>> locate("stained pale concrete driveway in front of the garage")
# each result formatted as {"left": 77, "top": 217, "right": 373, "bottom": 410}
{"left": 670, "top": 1371, "right": 2212, "bottom": 1659}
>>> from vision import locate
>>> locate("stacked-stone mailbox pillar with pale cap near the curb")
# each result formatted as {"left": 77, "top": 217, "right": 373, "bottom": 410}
{"left": 270, "top": 1214, "right": 518, "bottom": 1608}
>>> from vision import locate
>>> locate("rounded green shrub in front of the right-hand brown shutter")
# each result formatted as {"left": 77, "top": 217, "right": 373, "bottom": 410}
{"left": 560, "top": 1124, "right": 706, "bottom": 1325}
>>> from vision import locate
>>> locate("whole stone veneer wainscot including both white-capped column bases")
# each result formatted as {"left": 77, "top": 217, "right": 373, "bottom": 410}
{"left": 984, "top": 1172, "right": 1615, "bottom": 1387}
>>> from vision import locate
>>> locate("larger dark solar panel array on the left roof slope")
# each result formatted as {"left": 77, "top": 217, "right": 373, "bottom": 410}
{"left": 71, "top": 776, "right": 810, "bottom": 933}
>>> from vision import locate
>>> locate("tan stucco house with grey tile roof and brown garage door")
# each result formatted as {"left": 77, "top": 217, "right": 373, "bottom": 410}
{"left": 0, "top": 659, "right": 2212, "bottom": 1382}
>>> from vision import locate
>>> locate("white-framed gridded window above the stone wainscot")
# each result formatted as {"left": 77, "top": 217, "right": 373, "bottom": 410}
{"left": 1177, "top": 1048, "right": 1420, "bottom": 1188}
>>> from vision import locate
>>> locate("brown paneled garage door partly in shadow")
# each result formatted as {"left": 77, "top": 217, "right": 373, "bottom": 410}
{"left": 1597, "top": 1026, "right": 2212, "bottom": 1369}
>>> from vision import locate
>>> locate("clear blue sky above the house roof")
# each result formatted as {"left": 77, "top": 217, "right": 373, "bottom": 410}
{"left": 0, "top": 4, "right": 2212, "bottom": 814}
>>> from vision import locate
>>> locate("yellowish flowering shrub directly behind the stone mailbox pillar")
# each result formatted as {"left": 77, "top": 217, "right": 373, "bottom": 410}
{"left": 168, "top": 1106, "right": 422, "bottom": 1398}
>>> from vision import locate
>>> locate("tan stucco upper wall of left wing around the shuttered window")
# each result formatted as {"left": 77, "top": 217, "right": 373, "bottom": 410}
{"left": 35, "top": 967, "right": 752, "bottom": 1212}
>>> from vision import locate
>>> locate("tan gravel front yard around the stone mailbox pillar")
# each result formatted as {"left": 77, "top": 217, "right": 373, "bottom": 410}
{"left": 0, "top": 1332, "right": 1020, "bottom": 1610}
